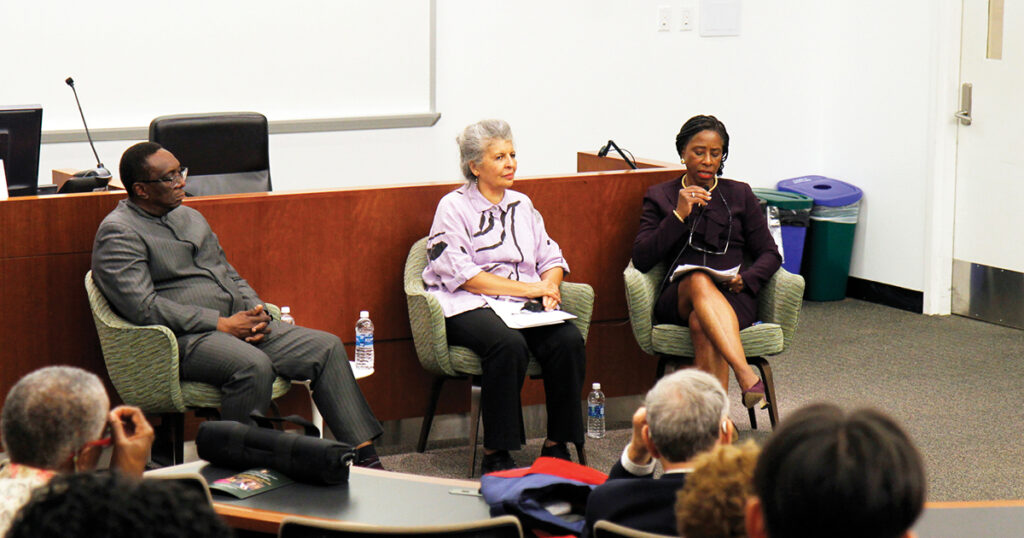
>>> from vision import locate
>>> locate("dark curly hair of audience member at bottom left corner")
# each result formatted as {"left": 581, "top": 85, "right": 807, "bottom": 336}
{"left": 7, "top": 472, "right": 231, "bottom": 538}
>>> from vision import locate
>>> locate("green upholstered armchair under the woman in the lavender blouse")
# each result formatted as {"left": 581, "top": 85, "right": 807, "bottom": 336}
{"left": 404, "top": 238, "right": 594, "bottom": 477}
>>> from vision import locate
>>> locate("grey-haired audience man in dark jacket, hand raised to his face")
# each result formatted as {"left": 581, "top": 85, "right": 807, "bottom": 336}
{"left": 583, "top": 369, "right": 733, "bottom": 538}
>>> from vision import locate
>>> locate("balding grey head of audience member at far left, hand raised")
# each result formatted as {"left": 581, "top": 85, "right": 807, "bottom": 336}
{"left": 0, "top": 366, "right": 110, "bottom": 469}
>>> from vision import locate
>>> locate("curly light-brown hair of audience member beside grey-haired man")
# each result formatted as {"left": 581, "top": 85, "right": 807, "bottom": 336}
{"left": 676, "top": 441, "right": 761, "bottom": 538}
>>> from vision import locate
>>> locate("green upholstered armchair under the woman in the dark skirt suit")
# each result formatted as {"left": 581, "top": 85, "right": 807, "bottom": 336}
{"left": 623, "top": 262, "right": 804, "bottom": 428}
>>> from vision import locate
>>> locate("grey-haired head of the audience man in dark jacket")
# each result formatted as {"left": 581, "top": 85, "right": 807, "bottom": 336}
{"left": 644, "top": 368, "right": 729, "bottom": 463}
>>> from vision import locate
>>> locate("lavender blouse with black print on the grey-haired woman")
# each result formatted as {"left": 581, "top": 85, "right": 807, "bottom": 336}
{"left": 423, "top": 182, "right": 569, "bottom": 318}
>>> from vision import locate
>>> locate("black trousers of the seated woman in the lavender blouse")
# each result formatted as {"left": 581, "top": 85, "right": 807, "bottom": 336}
{"left": 445, "top": 308, "right": 587, "bottom": 450}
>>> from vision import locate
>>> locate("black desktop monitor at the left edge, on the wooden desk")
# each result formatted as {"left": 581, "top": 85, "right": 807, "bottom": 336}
{"left": 0, "top": 105, "right": 43, "bottom": 197}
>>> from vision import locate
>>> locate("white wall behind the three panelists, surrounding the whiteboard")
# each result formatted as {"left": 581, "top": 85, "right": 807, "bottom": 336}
{"left": 41, "top": 0, "right": 950, "bottom": 290}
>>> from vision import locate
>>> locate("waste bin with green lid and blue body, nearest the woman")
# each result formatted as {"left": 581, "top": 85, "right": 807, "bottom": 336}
{"left": 754, "top": 189, "right": 814, "bottom": 275}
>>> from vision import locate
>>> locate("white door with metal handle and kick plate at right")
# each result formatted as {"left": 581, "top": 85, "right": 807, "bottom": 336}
{"left": 952, "top": 0, "right": 1024, "bottom": 327}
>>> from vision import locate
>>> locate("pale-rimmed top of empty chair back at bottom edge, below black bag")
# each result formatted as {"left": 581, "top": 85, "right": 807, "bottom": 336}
{"left": 278, "top": 515, "right": 522, "bottom": 538}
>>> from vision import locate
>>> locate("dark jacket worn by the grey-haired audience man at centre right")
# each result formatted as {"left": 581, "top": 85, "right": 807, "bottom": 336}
{"left": 582, "top": 462, "right": 686, "bottom": 538}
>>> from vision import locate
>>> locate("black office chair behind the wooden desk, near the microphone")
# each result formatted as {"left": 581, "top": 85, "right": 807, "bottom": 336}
{"left": 150, "top": 112, "right": 271, "bottom": 196}
